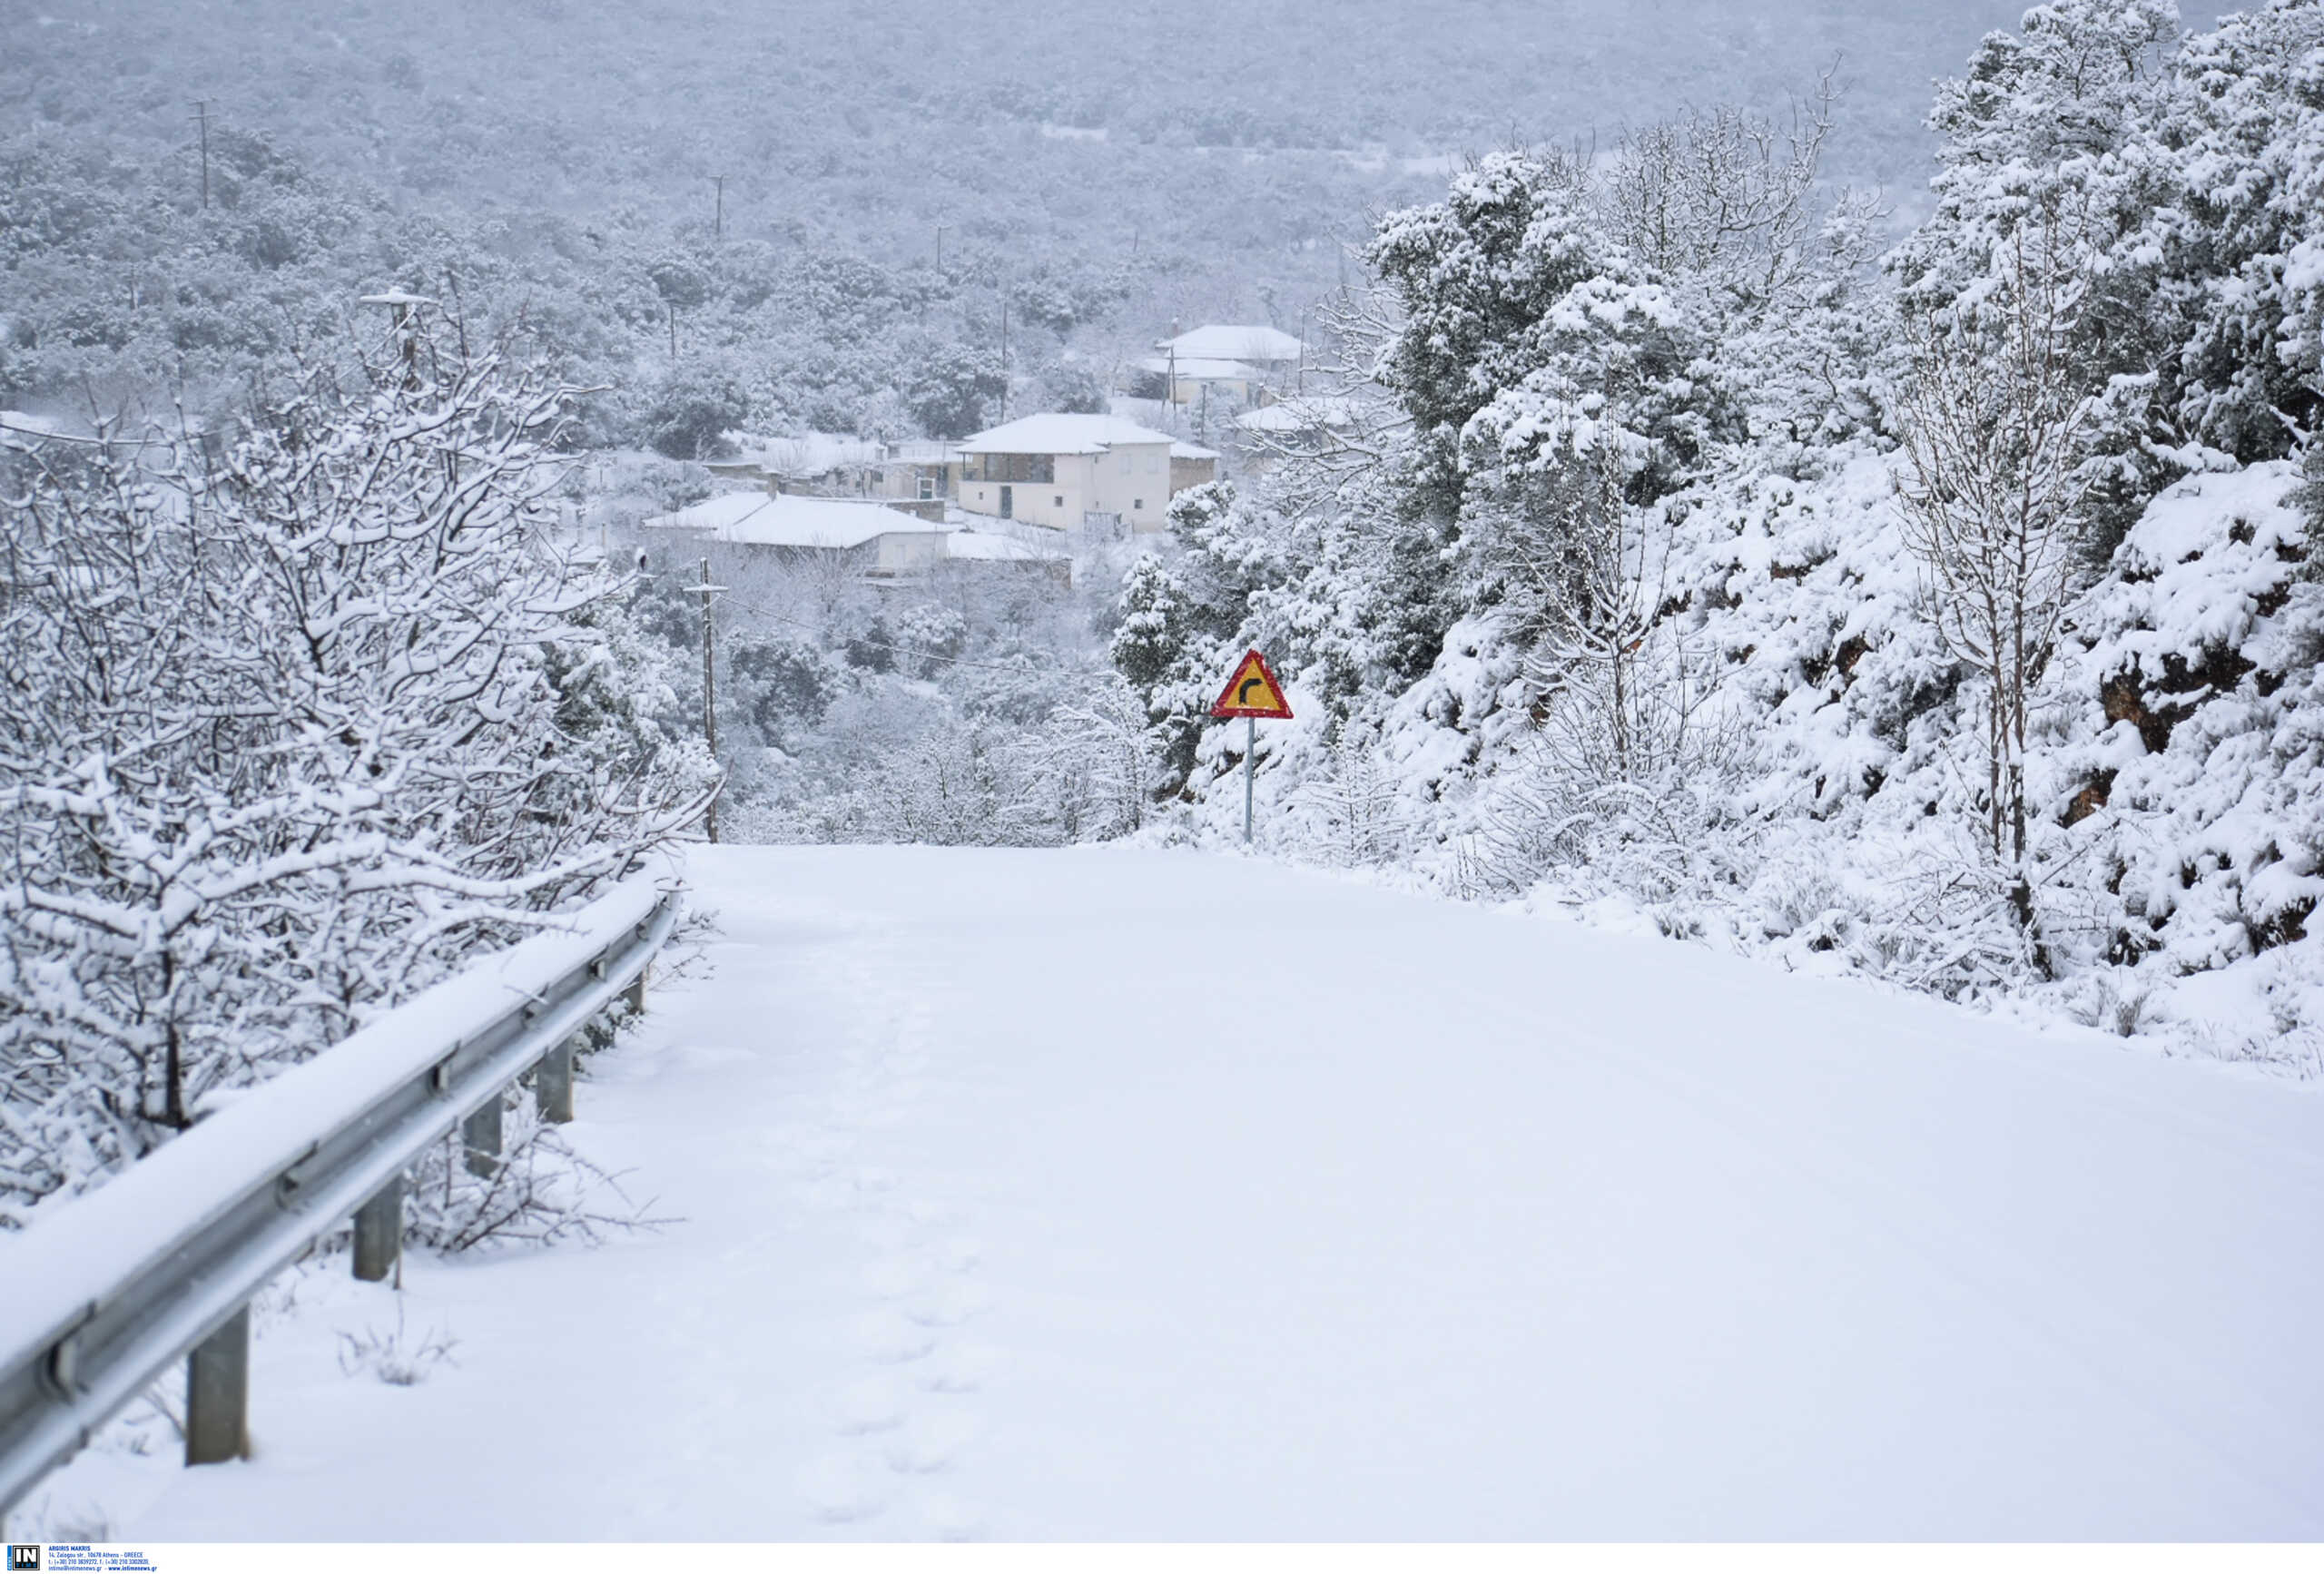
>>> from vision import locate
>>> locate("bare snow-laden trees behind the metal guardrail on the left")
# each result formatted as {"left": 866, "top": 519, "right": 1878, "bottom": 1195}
{"left": 0, "top": 307, "right": 709, "bottom": 1221}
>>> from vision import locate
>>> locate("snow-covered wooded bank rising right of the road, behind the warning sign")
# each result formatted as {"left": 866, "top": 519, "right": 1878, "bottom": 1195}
{"left": 1113, "top": 0, "right": 2324, "bottom": 1077}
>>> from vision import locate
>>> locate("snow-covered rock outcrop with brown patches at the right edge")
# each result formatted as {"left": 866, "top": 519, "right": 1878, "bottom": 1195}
{"left": 2059, "top": 463, "right": 2324, "bottom": 1035}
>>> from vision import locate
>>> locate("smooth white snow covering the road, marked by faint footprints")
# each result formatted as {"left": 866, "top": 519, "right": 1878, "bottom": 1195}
{"left": 32, "top": 849, "right": 2324, "bottom": 1541}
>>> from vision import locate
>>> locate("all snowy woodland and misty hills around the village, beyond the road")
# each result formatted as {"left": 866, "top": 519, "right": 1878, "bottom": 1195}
{"left": 0, "top": 0, "right": 2324, "bottom": 1242}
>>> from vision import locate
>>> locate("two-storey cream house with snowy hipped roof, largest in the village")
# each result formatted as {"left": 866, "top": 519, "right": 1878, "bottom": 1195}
{"left": 958, "top": 414, "right": 1171, "bottom": 533}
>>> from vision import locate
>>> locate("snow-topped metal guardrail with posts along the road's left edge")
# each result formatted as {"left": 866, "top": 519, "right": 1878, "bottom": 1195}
{"left": 0, "top": 879, "right": 679, "bottom": 1509}
